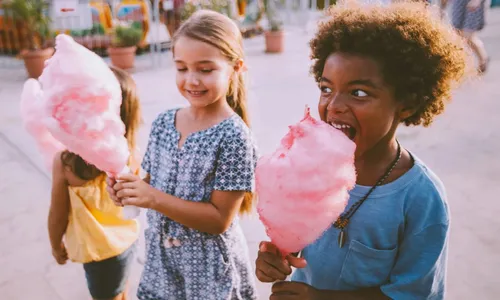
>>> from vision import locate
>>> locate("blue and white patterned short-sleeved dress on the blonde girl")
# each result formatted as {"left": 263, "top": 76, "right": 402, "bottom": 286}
{"left": 137, "top": 110, "right": 257, "bottom": 300}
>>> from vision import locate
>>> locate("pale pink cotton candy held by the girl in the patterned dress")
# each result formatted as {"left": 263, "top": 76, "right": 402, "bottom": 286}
{"left": 21, "top": 34, "right": 139, "bottom": 218}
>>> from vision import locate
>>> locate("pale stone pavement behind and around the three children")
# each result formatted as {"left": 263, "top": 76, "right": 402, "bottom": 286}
{"left": 0, "top": 9, "right": 500, "bottom": 300}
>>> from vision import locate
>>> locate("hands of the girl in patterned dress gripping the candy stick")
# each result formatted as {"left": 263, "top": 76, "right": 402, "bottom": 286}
{"left": 110, "top": 174, "right": 155, "bottom": 208}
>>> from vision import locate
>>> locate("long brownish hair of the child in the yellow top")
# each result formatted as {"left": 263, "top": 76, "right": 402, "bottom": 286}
{"left": 61, "top": 67, "right": 141, "bottom": 180}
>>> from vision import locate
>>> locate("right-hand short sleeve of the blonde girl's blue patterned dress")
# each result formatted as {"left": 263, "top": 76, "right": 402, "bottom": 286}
{"left": 214, "top": 132, "right": 257, "bottom": 192}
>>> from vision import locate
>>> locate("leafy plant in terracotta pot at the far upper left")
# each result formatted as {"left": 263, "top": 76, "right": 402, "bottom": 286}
{"left": 3, "top": 0, "right": 54, "bottom": 78}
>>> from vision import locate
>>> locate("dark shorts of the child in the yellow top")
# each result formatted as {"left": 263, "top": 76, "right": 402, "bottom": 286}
{"left": 83, "top": 245, "right": 136, "bottom": 300}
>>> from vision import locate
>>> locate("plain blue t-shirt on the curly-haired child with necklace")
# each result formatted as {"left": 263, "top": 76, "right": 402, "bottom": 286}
{"left": 292, "top": 158, "right": 450, "bottom": 300}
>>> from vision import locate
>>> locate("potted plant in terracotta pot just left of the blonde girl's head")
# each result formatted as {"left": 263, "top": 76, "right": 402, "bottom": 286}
{"left": 108, "top": 24, "right": 142, "bottom": 70}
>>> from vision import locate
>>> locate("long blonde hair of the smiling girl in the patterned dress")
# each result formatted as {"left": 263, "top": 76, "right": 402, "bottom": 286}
{"left": 172, "top": 10, "right": 254, "bottom": 213}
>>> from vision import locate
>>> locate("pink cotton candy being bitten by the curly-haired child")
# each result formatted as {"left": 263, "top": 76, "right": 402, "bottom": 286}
{"left": 256, "top": 109, "right": 356, "bottom": 255}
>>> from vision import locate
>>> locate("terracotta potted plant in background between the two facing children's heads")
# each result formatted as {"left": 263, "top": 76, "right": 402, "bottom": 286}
{"left": 264, "top": 0, "right": 285, "bottom": 53}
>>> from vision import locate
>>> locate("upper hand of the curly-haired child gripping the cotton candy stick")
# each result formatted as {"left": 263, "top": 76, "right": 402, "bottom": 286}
{"left": 255, "top": 242, "right": 307, "bottom": 282}
